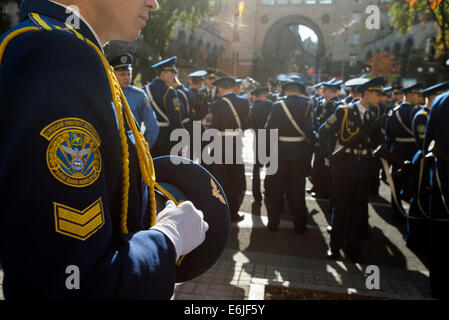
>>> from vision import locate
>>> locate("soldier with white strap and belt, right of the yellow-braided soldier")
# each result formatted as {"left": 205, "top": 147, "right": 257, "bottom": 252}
{"left": 385, "top": 83, "right": 425, "bottom": 222}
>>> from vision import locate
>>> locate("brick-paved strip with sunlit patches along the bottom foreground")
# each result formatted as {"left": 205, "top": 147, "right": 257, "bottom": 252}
{"left": 173, "top": 250, "right": 431, "bottom": 300}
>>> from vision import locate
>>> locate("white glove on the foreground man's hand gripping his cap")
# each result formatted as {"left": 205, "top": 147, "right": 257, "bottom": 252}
{"left": 151, "top": 200, "right": 209, "bottom": 261}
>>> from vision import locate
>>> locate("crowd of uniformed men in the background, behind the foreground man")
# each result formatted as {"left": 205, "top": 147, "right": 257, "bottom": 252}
{"left": 110, "top": 53, "right": 449, "bottom": 298}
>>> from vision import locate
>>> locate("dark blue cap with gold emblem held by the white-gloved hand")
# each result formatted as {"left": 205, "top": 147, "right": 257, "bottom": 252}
{"left": 153, "top": 156, "right": 231, "bottom": 283}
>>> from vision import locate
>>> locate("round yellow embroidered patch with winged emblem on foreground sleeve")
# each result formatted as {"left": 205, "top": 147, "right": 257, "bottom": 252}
{"left": 40, "top": 118, "right": 101, "bottom": 187}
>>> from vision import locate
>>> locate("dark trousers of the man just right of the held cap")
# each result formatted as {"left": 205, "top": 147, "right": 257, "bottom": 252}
{"left": 208, "top": 164, "right": 246, "bottom": 219}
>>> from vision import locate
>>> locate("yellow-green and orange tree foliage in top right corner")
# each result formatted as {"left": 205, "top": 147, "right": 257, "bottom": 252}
{"left": 389, "top": 0, "right": 449, "bottom": 63}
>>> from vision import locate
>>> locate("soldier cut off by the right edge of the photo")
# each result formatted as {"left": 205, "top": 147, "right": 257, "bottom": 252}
{"left": 424, "top": 93, "right": 449, "bottom": 299}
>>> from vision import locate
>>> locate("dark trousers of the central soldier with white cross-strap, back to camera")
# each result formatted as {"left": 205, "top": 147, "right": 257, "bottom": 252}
{"left": 265, "top": 160, "right": 307, "bottom": 233}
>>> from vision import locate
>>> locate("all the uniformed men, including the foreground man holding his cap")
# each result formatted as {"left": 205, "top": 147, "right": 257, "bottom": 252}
{"left": 0, "top": 0, "right": 449, "bottom": 299}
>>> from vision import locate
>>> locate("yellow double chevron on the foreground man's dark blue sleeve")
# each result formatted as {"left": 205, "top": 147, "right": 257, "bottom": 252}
{"left": 53, "top": 197, "right": 105, "bottom": 241}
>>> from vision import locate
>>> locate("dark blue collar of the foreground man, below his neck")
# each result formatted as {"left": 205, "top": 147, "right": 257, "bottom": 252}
{"left": 20, "top": 0, "right": 103, "bottom": 50}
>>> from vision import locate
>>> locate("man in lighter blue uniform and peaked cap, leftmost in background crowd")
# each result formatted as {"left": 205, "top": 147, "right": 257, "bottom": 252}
{"left": 109, "top": 53, "right": 159, "bottom": 150}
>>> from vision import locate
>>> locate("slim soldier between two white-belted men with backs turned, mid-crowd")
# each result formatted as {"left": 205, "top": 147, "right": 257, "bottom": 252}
{"left": 249, "top": 88, "right": 273, "bottom": 202}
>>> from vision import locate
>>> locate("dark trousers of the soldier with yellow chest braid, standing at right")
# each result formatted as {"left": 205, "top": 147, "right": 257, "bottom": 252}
{"left": 330, "top": 170, "right": 369, "bottom": 259}
